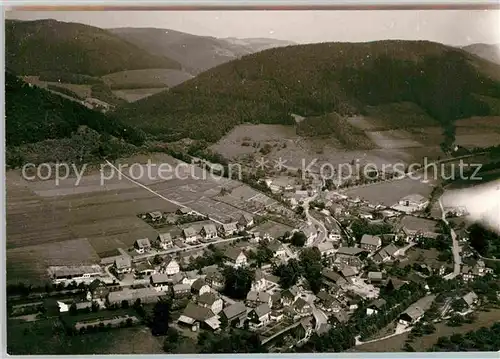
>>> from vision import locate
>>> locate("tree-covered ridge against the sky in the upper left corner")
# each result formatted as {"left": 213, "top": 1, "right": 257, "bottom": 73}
{"left": 5, "top": 20, "right": 181, "bottom": 76}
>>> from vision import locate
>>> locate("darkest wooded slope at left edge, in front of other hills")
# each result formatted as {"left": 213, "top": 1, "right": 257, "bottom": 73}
{"left": 5, "top": 71, "right": 144, "bottom": 166}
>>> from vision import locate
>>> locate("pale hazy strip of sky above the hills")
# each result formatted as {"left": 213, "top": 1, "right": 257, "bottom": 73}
{"left": 6, "top": 10, "right": 500, "bottom": 46}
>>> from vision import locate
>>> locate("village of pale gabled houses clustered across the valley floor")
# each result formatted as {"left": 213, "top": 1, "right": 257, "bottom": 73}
{"left": 8, "top": 155, "right": 500, "bottom": 352}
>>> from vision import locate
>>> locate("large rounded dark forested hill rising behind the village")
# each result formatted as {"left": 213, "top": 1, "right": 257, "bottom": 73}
{"left": 119, "top": 40, "right": 500, "bottom": 141}
